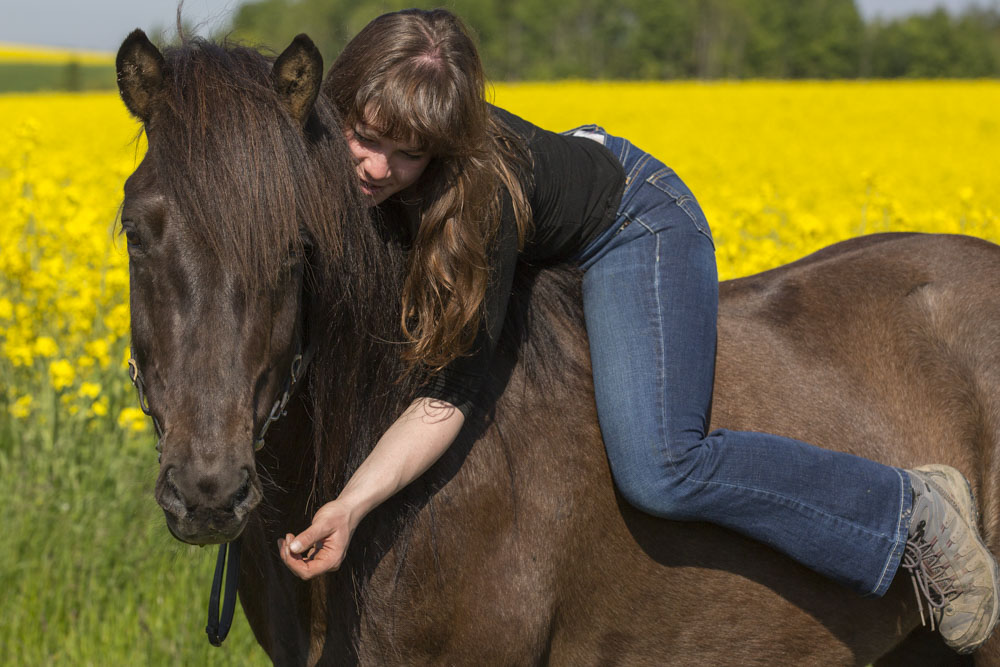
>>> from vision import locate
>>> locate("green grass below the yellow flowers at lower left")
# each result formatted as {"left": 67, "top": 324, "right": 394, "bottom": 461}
{"left": 0, "top": 418, "right": 268, "bottom": 667}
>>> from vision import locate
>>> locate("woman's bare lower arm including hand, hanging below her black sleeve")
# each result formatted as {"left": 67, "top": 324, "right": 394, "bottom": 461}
{"left": 278, "top": 398, "right": 465, "bottom": 579}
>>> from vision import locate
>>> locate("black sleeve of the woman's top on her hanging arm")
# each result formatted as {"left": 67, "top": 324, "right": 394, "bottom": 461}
{"left": 417, "top": 192, "right": 518, "bottom": 417}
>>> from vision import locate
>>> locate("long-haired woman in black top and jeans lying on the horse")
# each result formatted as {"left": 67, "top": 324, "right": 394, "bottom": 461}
{"left": 279, "top": 10, "right": 998, "bottom": 652}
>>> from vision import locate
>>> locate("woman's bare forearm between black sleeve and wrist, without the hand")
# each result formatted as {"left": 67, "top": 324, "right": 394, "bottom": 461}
{"left": 338, "top": 398, "right": 465, "bottom": 523}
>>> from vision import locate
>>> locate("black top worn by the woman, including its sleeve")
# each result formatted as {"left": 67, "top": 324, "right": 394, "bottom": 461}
{"left": 394, "top": 107, "right": 625, "bottom": 416}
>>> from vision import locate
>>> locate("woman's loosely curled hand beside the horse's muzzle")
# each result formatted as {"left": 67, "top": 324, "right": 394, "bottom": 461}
{"left": 278, "top": 499, "right": 357, "bottom": 579}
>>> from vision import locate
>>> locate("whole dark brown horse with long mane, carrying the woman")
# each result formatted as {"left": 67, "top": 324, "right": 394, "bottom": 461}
{"left": 118, "top": 32, "right": 1000, "bottom": 665}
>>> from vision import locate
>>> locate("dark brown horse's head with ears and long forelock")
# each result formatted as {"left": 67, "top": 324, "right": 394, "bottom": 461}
{"left": 117, "top": 31, "right": 350, "bottom": 544}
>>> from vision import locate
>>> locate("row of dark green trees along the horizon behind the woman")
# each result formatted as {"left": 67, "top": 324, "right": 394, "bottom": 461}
{"left": 221, "top": 0, "right": 1000, "bottom": 80}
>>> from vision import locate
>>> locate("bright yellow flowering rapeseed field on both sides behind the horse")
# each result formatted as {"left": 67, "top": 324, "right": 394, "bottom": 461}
{"left": 0, "top": 81, "right": 1000, "bottom": 441}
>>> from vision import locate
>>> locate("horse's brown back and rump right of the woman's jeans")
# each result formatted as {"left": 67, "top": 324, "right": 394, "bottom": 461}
{"left": 713, "top": 234, "right": 1000, "bottom": 482}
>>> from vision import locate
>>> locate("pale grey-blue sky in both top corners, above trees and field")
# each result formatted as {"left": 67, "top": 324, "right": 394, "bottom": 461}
{"left": 0, "top": 0, "right": 1000, "bottom": 51}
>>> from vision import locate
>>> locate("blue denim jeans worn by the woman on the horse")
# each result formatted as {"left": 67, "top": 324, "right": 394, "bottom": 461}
{"left": 573, "top": 126, "right": 912, "bottom": 596}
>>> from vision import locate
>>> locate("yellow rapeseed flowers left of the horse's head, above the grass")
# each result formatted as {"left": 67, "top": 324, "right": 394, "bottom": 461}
{"left": 0, "top": 93, "right": 145, "bottom": 440}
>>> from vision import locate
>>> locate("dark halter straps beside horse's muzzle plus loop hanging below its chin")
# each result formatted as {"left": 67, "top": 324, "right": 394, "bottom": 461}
{"left": 128, "top": 341, "right": 315, "bottom": 646}
